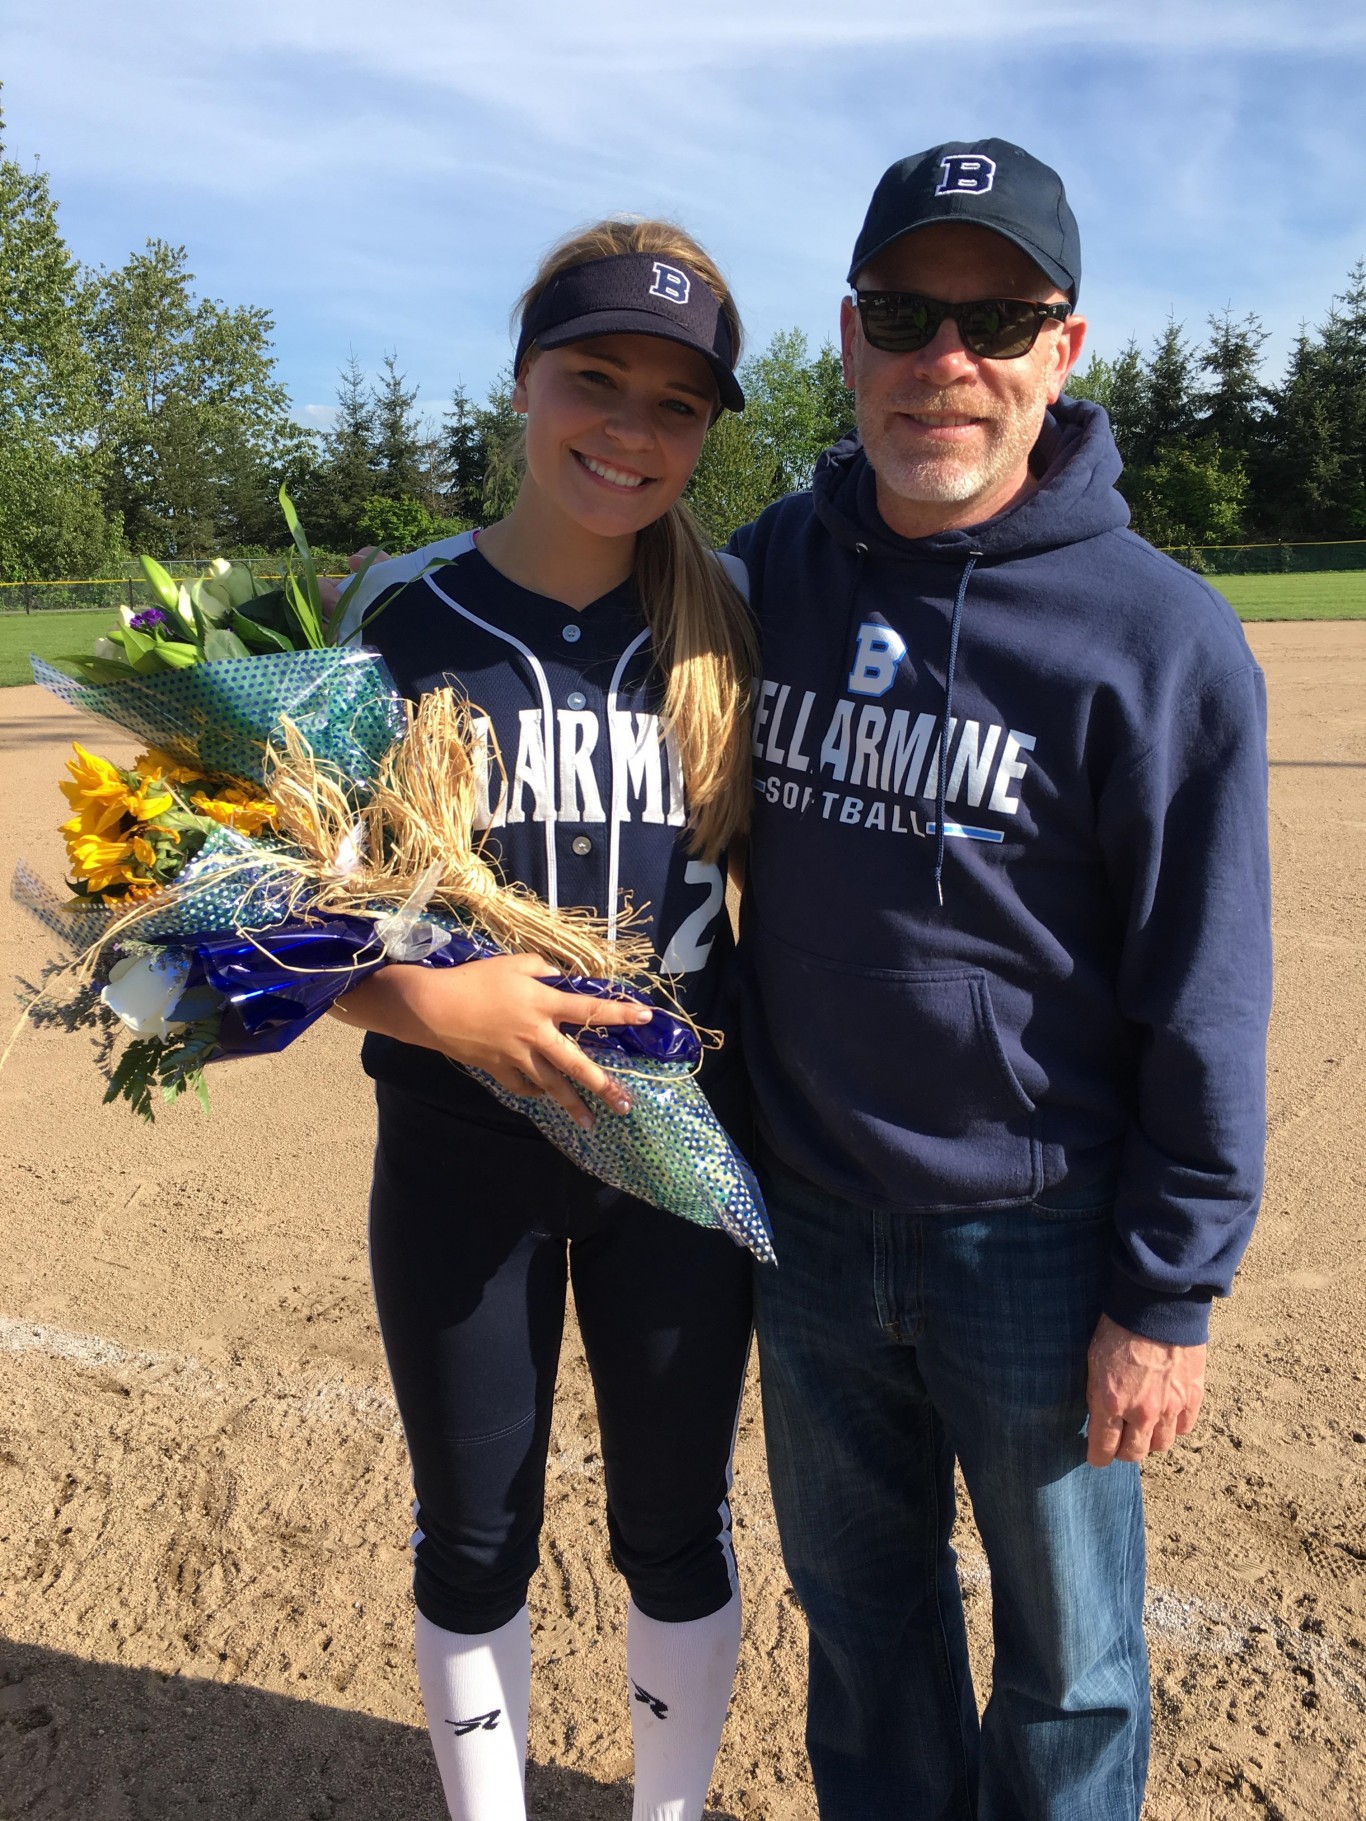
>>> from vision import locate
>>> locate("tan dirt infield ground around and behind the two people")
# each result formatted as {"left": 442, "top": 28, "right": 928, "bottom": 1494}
{"left": 0, "top": 625, "right": 1366, "bottom": 1821}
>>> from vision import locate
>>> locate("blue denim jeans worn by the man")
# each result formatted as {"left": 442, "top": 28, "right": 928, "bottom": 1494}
{"left": 754, "top": 1169, "right": 1149, "bottom": 1821}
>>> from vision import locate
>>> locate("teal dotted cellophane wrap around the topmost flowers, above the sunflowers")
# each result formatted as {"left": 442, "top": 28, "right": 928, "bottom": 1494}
{"left": 31, "top": 646, "right": 406, "bottom": 790}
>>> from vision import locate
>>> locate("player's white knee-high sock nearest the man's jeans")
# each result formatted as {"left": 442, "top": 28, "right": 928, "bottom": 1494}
{"left": 627, "top": 1592, "right": 739, "bottom": 1821}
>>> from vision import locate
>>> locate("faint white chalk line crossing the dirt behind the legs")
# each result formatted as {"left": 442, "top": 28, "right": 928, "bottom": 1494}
{"left": 0, "top": 1315, "right": 1366, "bottom": 1714}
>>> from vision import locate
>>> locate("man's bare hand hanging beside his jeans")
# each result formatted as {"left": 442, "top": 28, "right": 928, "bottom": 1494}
{"left": 1086, "top": 1315, "right": 1206, "bottom": 1468}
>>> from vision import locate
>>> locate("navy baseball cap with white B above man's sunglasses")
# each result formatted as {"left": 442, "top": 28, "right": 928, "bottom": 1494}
{"left": 849, "top": 138, "right": 1082, "bottom": 302}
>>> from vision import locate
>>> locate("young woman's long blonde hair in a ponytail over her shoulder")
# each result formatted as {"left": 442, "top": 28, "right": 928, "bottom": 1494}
{"left": 515, "top": 217, "right": 759, "bottom": 860}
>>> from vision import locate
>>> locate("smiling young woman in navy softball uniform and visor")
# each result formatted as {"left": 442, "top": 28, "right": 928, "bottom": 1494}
{"left": 331, "top": 220, "right": 754, "bottom": 1821}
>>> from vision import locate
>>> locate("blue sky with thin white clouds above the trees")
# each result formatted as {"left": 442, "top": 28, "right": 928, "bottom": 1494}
{"left": 0, "top": 0, "right": 1366, "bottom": 422}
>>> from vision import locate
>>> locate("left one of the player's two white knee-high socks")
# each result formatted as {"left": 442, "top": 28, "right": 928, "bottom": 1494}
{"left": 417, "top": 1606, "right": 532, "bottom": 1821}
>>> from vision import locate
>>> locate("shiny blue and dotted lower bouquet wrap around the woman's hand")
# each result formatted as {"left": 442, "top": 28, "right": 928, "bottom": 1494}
{"left": 163, "top": 918, "right": 774, "bottom": 1264}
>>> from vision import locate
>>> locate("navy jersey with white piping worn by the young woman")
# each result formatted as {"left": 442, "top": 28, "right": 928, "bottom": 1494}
{"left": 348, "top": 534, "right": 732, "bottom": 1120}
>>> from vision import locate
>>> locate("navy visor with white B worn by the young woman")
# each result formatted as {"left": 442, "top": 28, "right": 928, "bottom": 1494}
{"left": 512, "top": 253, "right": 745, "bottom": 412}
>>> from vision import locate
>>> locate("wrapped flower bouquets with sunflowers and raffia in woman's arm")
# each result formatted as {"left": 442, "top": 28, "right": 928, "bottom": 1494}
{"left": 15, "top": 490, "right": 772, "bottom": 1260}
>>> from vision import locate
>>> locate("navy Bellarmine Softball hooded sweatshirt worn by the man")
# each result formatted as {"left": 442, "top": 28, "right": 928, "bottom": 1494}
{"left": 732, "top": 399, "right": 1271, "bottom": 1344}
